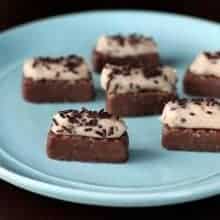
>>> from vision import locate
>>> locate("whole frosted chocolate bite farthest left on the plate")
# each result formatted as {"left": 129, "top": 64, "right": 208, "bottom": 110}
{"left": 22, "top": 55, "right": 94, "bottom": 103}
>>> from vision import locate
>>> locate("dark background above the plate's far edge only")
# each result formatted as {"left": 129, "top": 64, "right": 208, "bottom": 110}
{"left": 0, "top": 0, "right": 220, "bottom": 29}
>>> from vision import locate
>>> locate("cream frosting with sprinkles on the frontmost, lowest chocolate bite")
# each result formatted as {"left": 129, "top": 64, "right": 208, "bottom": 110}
{"left": 51, "top": 110, "right": 127, "bottom": 138}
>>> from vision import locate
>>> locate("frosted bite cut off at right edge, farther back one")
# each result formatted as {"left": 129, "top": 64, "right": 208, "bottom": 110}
{"left": 184, "top": 51, "right": 220, "bottom": 98}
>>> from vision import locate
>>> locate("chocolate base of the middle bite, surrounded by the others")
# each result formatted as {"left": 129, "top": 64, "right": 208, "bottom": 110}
{"left": 106, "top": 91, "right": 177, "bottom": 116}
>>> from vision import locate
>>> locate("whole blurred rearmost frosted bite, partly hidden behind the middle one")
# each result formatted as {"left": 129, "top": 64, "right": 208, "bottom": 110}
{"left": 93, "top": 34, "right": 160, "bottom": 72}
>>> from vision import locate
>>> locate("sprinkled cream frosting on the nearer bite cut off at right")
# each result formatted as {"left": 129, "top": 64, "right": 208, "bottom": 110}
{"left": 161, "top": 101, "right": 220, "bottom": 129}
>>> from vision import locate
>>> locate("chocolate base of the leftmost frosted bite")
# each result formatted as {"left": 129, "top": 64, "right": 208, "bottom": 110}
{"left": 22, "top": 77, "right": 94, "bottom": 103}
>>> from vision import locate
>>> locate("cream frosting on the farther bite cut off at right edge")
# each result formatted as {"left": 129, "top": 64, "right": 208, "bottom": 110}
{"left": 189, "top": 53, "right": 220, "bottom": 77}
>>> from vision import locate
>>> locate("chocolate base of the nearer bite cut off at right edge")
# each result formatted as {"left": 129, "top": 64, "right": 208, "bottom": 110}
{"left": 162, "top": 125, "right": 220, "bottom": 152}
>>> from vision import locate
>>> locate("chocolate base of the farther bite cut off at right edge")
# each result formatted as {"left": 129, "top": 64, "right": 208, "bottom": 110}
{"left": 184, "top": 71, "right": 220, "bottom": 98}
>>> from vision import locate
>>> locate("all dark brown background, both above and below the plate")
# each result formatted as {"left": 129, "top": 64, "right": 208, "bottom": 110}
{"left": 0, "top": 0, "right": 220, "bottom": 220}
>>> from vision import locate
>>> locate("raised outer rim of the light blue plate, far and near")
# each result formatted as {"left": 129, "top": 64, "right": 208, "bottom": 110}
{"left": 0, "top": 10, "right": 220, "bottom": 207}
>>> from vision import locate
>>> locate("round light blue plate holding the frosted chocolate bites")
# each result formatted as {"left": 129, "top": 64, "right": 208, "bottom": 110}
{"left": 0, "top": 11, "right": 220, "bottom": 206}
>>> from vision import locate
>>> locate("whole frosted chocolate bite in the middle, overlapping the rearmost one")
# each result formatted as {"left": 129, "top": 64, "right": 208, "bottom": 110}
{"left": 101, "top": 64, "right": 177, "bottom": 116}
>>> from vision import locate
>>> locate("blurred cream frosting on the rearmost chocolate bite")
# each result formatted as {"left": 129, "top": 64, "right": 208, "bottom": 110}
{"left": 96, "top": 36, "right": 158, "bottom": 57}
